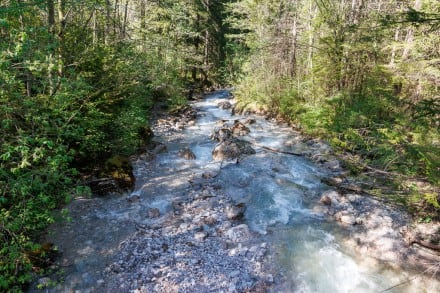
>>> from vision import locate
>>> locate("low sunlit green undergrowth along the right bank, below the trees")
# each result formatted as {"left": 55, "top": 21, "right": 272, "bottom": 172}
{"left": 235, "top": 72, "right": 440, "bottom": 219}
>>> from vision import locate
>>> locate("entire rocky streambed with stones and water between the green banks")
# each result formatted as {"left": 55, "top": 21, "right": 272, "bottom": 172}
{"left": 30, "top": 90, "right": 440, "bottom": 292}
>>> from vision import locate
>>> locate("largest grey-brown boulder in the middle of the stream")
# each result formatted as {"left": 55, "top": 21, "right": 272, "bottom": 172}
{"left": 212, "top": 139, "right": 255, "bottom": 161}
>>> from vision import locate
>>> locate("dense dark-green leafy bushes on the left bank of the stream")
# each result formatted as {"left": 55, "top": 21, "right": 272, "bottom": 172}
{"left": 0, "top": 37, "right": 179, "bottom": 291}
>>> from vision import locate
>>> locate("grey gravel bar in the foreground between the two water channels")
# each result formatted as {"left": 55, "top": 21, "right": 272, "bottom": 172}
{"left": 105, "top": 185, "right": 273, "bottom": 292}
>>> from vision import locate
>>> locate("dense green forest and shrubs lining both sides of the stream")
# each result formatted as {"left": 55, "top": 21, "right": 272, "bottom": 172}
{"left": 0, "top": 0, "right": 440, "bottom": 291}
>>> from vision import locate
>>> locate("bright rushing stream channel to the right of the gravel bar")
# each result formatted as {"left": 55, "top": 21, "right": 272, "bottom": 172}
{"left": 177, "top": 91, "right": 432, "bottom": 292}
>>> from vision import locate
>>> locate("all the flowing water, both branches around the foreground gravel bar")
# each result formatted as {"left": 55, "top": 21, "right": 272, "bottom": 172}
{"left": 30, "top": 91, "right": 438, "bottom": 293}
